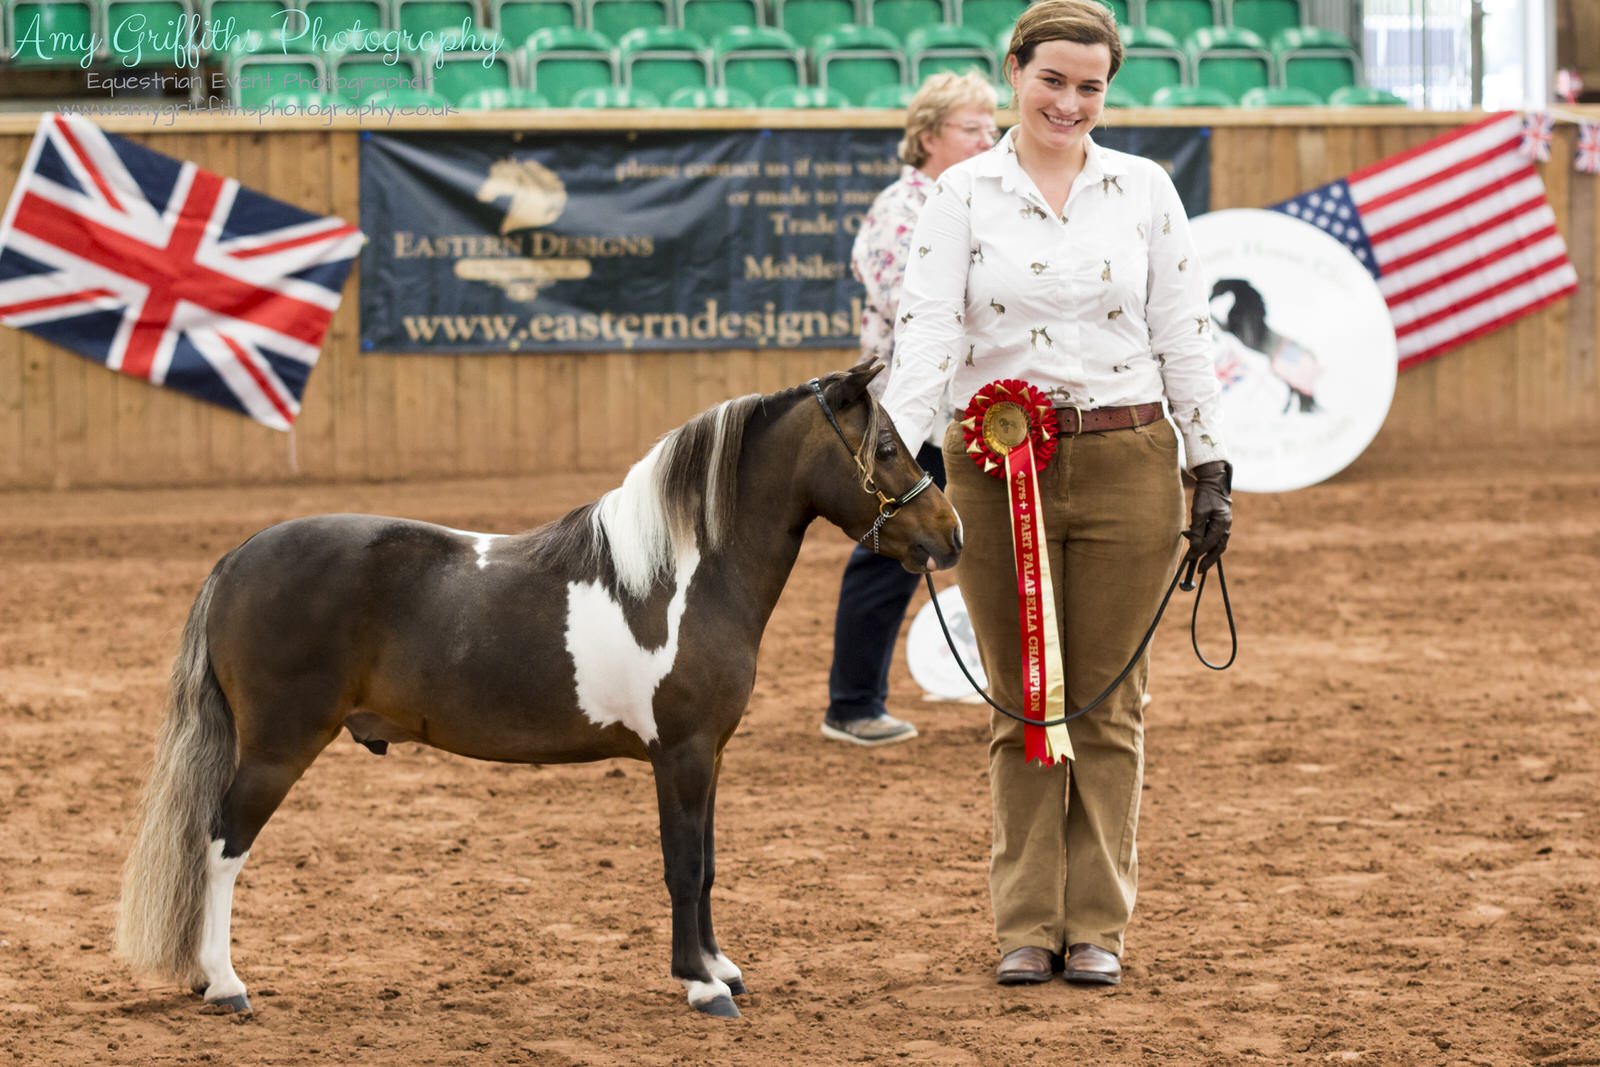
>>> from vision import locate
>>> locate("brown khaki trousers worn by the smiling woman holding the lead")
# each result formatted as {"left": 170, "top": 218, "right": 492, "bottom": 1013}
{"left": 944, "top": 421, "right": 1184, "bottom": 955}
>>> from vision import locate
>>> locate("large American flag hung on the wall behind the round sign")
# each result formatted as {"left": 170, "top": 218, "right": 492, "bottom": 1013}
{"left": 1274, "top": 112, "right": 1578, "bottom": 370}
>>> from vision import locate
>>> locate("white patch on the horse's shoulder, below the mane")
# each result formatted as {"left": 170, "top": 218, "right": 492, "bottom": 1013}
{"left": 566, "top": 544, "right": 699, "bottom": 744}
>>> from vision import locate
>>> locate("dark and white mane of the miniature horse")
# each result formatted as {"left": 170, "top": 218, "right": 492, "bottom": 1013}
{"left": 539, "top": 374, "right": 882, "bottom": 597}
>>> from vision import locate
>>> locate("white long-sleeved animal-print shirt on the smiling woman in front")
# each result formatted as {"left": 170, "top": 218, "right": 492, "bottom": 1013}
{"left": 883, "top": 130, "right": 1227, "bottom": 467}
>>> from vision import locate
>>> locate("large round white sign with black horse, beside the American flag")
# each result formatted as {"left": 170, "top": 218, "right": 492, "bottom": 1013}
{"left": 1194, "top": 210, "right": 1398, "bottom": 493}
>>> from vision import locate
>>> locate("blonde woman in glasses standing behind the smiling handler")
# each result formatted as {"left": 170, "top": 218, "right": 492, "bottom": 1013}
{"left": 822, "top": 74, "right": 998, "bottom": 745}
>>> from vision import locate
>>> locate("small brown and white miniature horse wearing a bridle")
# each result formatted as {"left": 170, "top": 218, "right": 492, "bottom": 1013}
{"left": 117, "top": 365, "right": 962, "bottom": 1016}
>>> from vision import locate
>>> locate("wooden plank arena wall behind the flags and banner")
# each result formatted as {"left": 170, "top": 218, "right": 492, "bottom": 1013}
{"left": 0, "top": 109, "right": 1600, "bottom": 490}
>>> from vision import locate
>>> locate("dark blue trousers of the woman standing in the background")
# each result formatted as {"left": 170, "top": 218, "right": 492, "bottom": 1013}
{"left": 827, "top": 445, "right": 944, "bottom": 721}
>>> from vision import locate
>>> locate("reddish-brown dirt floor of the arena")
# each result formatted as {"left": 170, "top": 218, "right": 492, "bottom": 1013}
{"left": 0, "top": 446, "right": 1600, "bottom": 1067}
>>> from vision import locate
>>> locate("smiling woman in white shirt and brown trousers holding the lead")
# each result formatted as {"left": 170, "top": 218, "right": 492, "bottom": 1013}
{"left": 883, "top": 0, "right": 1232, "bottom": 984}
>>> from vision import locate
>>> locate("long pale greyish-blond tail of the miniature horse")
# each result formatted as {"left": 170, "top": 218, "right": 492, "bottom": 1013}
{"left": 117, "top": 557, "right": 238, "bottom": 982}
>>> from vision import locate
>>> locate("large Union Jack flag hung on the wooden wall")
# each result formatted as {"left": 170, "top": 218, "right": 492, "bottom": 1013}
{"left": 0, "top": 115, "right": 363, "bottom": 430}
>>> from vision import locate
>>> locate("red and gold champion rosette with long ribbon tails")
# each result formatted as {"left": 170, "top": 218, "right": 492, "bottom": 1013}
{"left": 962, "top": 379, "right": 1072, "bottom": 766}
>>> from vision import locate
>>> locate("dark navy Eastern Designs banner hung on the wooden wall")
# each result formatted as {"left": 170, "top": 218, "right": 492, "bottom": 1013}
{"left": 362, "top": 128, "right": 1211, "bottom": 352}
